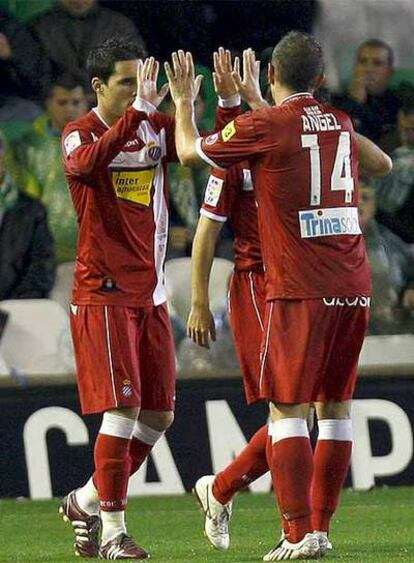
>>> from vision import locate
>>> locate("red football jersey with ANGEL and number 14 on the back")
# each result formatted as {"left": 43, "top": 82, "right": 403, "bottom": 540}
{"left": 197, "top": 93, "right": 371, "bottom": 300}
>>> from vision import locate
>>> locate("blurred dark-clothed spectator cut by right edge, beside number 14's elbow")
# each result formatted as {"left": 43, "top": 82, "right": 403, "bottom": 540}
{"left": 375, "top": 94, "right": 414, "bottom": 243}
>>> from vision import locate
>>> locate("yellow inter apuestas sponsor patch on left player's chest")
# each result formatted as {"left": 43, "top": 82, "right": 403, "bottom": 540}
{"left": 112, "top": 168, "right": 155, "bottom": 207}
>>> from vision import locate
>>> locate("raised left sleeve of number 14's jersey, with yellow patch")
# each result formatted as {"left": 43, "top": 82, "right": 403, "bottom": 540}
{"left": 196, "top": 108, "right": 277, "bottom": 168}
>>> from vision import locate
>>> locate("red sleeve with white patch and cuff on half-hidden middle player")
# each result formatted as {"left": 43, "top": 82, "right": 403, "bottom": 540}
{"left": 200, "top": 165, "right": 241, "bottom": 223}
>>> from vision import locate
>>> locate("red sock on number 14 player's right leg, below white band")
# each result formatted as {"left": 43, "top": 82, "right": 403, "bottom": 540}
{"left": 312, "top": 440, "right": 352, "bottom": 532}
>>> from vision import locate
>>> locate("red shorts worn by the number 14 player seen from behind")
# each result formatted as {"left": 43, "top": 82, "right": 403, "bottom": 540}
{"left": 260, "top": 297, "right": 369, "bottom": 404}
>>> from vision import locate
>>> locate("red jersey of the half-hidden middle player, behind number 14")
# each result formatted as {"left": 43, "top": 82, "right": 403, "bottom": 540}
{"left": 200, "top": 162, "right": 263, "bottom": 270}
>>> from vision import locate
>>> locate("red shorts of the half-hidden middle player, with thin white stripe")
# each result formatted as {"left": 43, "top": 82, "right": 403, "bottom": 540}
{"left": 229, "top": 272, "right": 266, "bottom": 404}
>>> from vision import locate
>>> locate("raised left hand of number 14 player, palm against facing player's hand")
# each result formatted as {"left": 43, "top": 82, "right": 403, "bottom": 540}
{"left": 164, "top": 50, "right": 203, "bottom": 105}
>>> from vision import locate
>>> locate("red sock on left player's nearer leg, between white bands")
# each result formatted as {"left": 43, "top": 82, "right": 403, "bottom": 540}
{"left": 93, "top": 433, "right": 130, "bottom": 512}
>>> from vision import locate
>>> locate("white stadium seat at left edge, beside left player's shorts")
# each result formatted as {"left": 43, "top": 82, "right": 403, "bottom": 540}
{"left": 0, "top": 299, "right": 74, "bottom": 376}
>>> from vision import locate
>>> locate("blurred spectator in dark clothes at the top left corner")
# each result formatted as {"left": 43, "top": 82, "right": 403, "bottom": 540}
{"left": 0, "top": 11, "right": 47, "bottom": 121}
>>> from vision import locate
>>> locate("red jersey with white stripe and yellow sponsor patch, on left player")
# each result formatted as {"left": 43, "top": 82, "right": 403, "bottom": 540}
{"left": 62, "top": 107, "right": 177, "bottom": 307}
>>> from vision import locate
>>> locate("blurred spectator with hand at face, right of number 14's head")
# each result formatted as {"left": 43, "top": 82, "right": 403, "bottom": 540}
{"left": 332, "top": 39, "right": 400, "bottom": 150}
